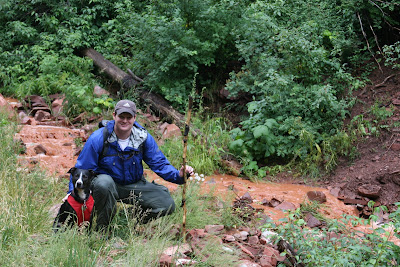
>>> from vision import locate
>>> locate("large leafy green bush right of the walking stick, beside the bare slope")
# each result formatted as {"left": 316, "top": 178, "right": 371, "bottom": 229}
{"left": 226, "top": 1, "right": 366, "bottom": 177}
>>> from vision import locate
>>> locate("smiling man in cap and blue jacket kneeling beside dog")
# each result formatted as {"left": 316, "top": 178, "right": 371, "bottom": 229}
{"left": 69, "top": 100, "right": 193, "bottom": 229}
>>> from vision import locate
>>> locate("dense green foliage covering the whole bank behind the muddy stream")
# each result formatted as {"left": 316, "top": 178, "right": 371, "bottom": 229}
{"left": 0, "top": 0, "right": 400, "bottom": 176}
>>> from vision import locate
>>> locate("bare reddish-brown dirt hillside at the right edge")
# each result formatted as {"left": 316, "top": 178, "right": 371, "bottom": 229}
{"left": 325, "top": 63, "right": 400, "bottom": 220}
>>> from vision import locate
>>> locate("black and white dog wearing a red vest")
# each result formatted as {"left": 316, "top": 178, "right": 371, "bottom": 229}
{"left": 53, "top": 167, "right": 96, "bottom": 232}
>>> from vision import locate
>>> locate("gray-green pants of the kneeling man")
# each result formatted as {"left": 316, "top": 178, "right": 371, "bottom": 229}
{"left": 92, "top": 174, "right": 175, "bottom": 229}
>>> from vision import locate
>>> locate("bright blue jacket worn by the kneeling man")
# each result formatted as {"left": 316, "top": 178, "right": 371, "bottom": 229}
{"left": 68, "top": 121, "right": 184, "bottom": 192}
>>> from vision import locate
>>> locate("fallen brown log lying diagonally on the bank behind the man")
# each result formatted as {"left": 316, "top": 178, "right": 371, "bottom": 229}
{"left": 83, "top": 48, "right": 199, "bottom": 137}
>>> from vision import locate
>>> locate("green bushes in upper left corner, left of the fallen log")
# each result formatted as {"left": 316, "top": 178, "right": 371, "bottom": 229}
{"left": 0, "top": 1, "right": 122, "bottom": 117}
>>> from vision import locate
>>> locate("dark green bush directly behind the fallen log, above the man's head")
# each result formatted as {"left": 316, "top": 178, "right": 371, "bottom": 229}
{"left": 103, "top": 0, "right": 247, "bottom": 110}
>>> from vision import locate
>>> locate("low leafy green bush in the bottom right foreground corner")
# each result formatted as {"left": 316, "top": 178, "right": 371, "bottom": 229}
{"left": 266, "top": 204, "right": 400, "bottom": 266}
